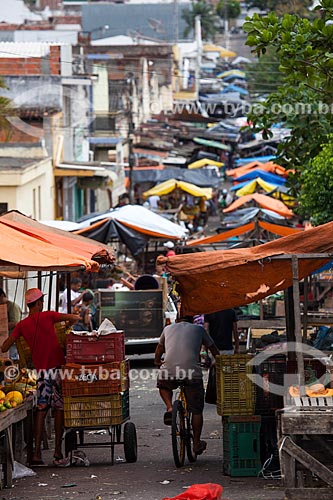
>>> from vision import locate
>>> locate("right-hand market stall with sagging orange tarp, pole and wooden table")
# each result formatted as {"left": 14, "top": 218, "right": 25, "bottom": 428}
{"left": 158, "top": 222, "right": 333, "bottom": 500}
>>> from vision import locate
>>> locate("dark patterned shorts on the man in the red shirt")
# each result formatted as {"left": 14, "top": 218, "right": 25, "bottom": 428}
{"left": 37, "top": 368, "right": 64, "bottom": 410}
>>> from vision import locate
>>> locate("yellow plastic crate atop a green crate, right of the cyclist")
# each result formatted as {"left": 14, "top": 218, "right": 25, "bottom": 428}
{"left": 216, "top": 354, "right": 255, "bottom": 416}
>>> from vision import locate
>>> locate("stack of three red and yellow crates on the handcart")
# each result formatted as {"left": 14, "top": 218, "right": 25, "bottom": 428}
{"left": 62, "top": 331, "right": 129, "bottom": 428}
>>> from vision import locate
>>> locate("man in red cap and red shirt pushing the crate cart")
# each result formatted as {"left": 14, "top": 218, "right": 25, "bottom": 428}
{"left": 1, "top": 288, "right": 80, "bottom": 467}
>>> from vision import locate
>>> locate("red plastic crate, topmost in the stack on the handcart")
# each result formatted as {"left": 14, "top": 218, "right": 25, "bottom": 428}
{"left": 66, "top": 330, "right": 125, "bottom": 364}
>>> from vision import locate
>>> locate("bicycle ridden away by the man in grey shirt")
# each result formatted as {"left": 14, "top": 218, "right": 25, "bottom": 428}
{"left": 171, "top": 385, "right": 197, "bottom": 467}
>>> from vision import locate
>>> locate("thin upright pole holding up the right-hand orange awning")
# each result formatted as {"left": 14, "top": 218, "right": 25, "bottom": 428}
{"left": 291, "top": 255, "right": 305, "bottom": 396}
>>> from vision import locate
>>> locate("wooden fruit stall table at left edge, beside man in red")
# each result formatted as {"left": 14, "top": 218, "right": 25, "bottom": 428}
{"left": 0, "top": 394, "right": 36, "bottom": 488}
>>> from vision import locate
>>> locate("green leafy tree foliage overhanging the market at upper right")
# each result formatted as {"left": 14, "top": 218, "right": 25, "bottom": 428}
{"left": 243, "top": 0, "right": 333, "bottom": 220}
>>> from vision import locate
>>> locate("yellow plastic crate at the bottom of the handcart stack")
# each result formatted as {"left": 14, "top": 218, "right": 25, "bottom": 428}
{"left": 64, "top": 391, "right": 129, "bottom": 428}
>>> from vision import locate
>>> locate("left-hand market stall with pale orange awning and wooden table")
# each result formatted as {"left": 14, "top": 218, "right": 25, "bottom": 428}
{"left": 0, "top": 211, "right": 114, "bottom": 487}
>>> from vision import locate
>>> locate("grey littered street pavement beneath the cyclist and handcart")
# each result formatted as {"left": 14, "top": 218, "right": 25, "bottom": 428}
{"left": 0, "top": 361, "right": 284, "bottom": 500}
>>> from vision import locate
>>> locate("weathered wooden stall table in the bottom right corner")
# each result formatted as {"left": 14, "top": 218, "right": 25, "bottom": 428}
{"left": 277, "top": 398, "right": 333, "bottom": 500}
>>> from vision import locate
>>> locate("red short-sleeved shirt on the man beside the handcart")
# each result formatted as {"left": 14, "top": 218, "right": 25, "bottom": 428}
{"left": 12, "top": 311, "right": 65, "bottom": 370}
